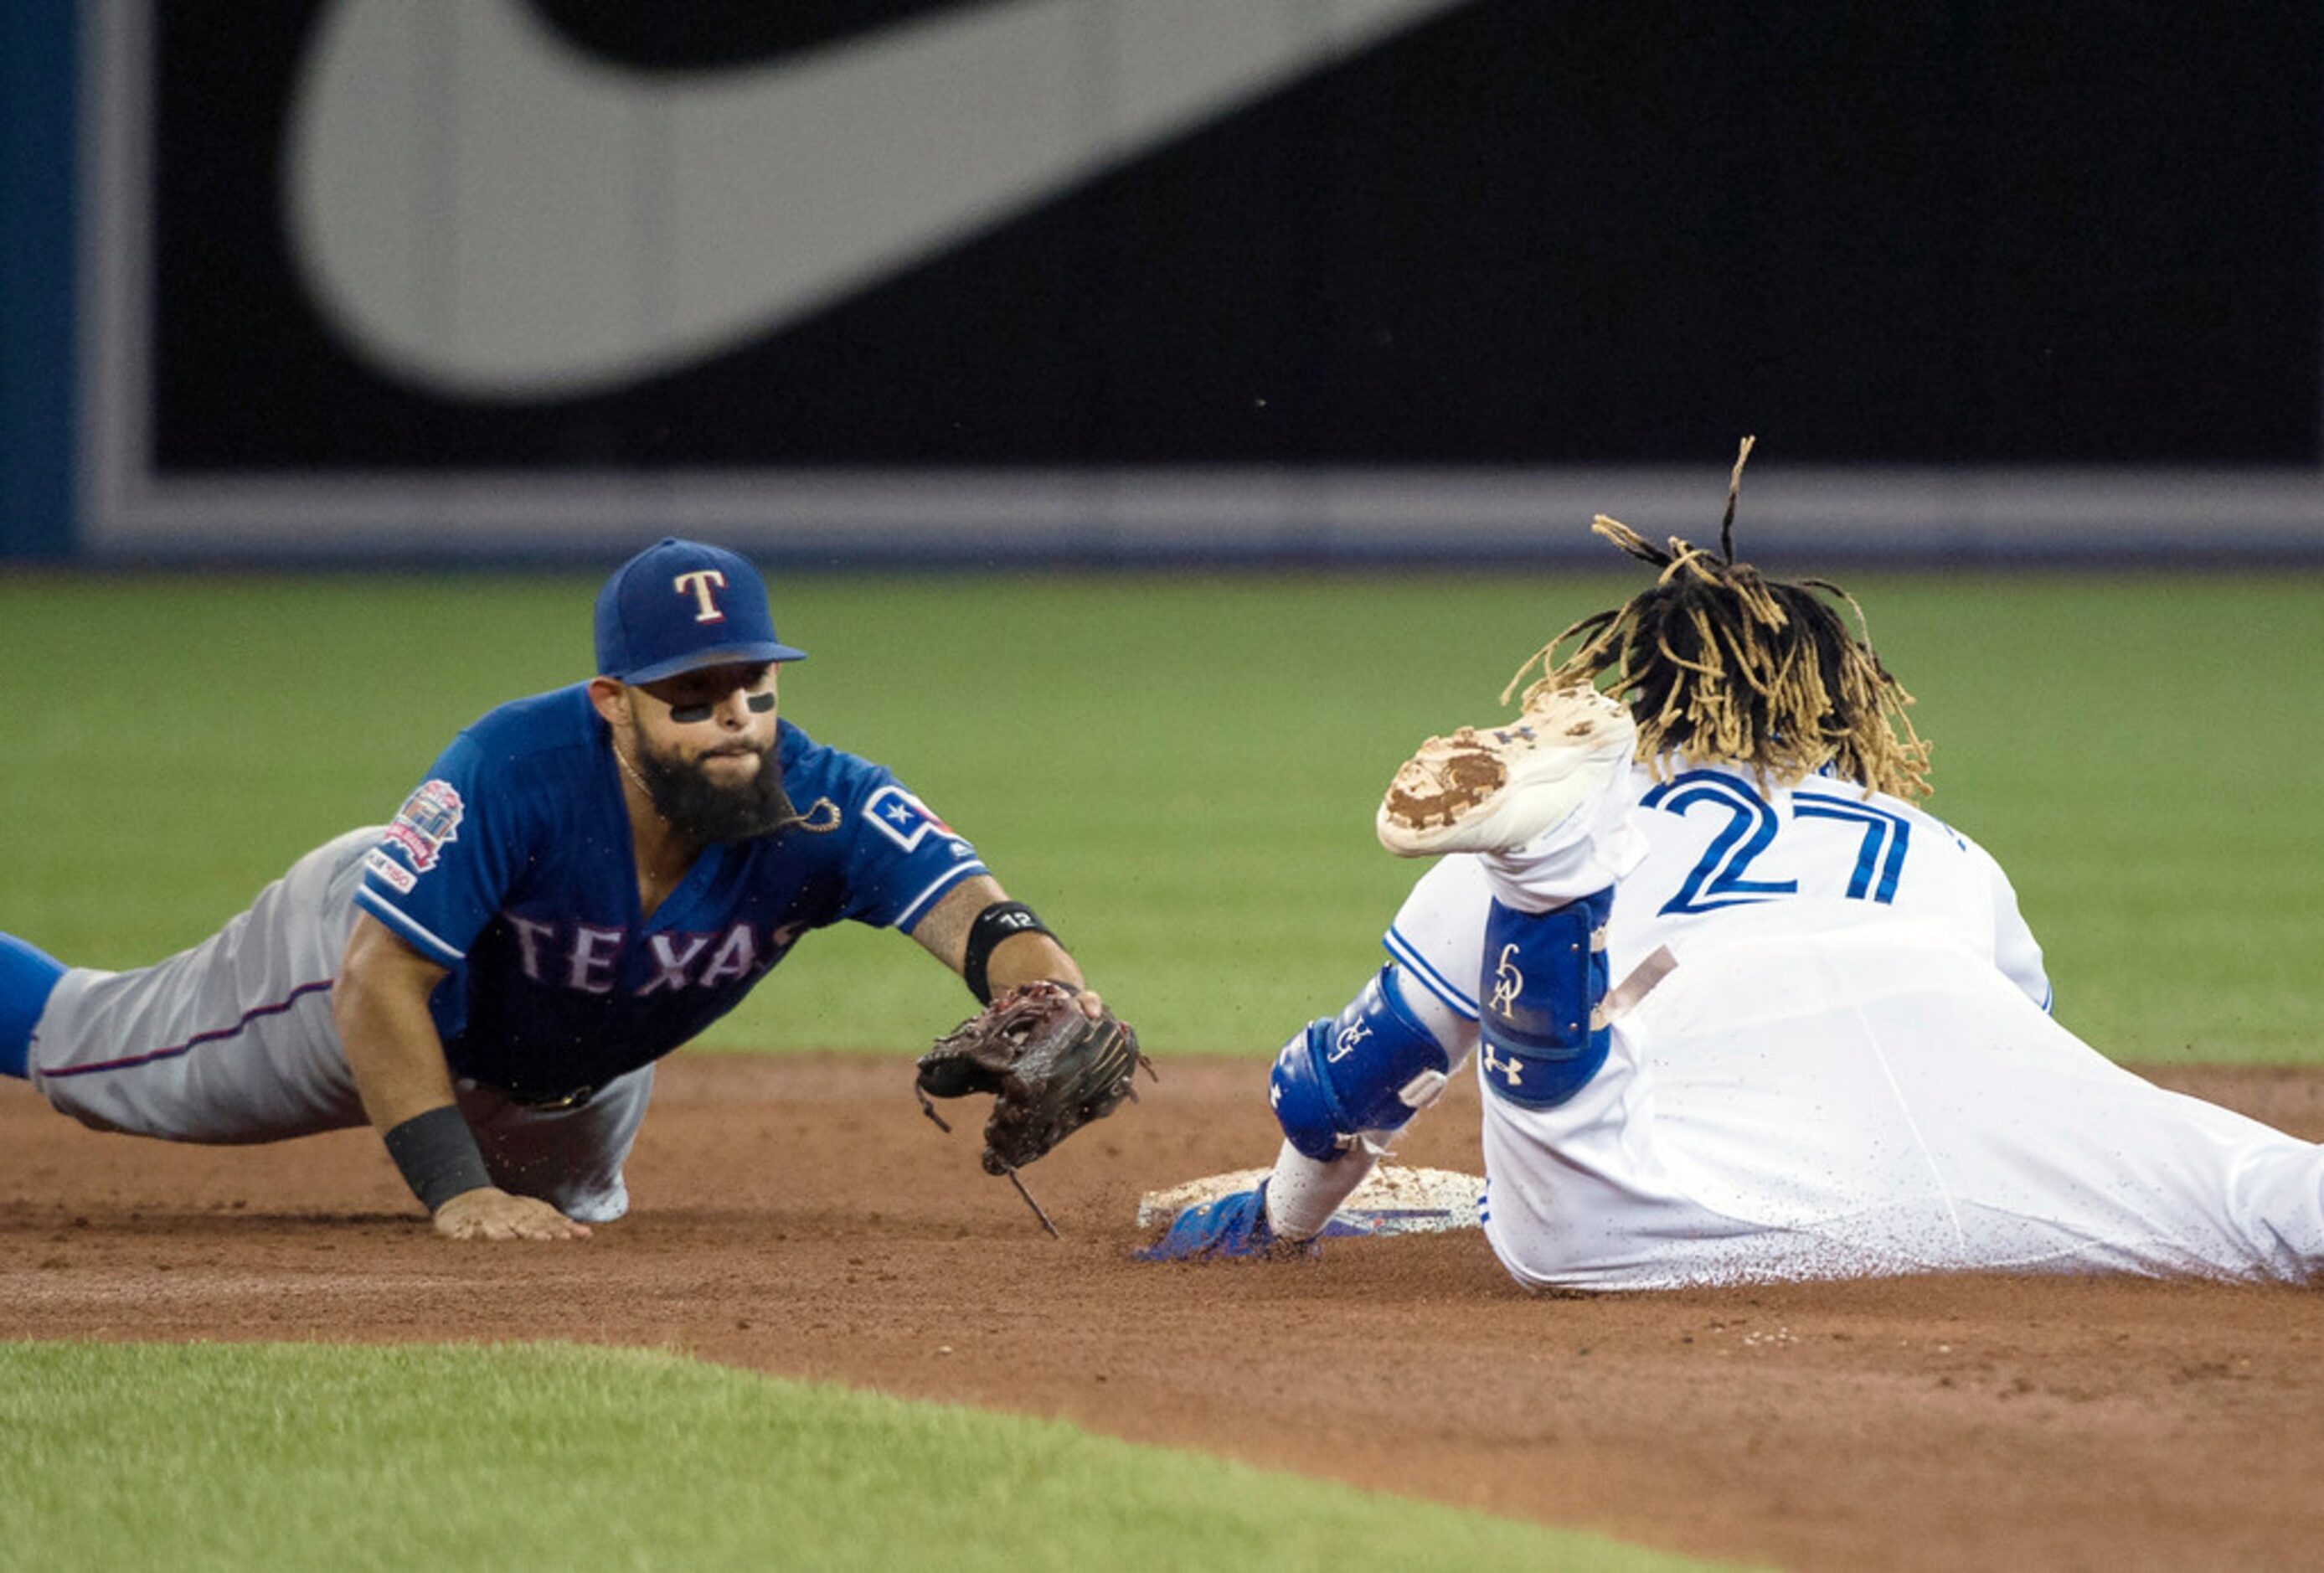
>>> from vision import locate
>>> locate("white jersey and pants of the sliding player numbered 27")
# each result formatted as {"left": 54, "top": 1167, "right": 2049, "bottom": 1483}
{"left": 1385, "top": 766, "right": 2324, "bottom": 1290}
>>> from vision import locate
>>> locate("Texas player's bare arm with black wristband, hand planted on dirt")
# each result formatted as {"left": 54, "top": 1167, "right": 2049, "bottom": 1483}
{"left": 330, "top": 913, "right": 588, "bottom": 1240}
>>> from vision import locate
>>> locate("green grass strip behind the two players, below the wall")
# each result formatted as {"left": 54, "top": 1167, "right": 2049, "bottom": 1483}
{"left": 0, "top": 574, "right": 2324, "bottom": 1062}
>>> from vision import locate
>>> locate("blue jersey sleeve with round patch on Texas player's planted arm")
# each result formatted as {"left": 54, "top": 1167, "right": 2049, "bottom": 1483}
{"left": 356, "top": 732, "right": 528, "bottom": 969}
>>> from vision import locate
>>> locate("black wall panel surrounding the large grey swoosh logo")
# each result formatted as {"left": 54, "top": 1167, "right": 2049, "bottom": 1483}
{"left": 0, "top": 0, "right": 2324, "bottom": 557}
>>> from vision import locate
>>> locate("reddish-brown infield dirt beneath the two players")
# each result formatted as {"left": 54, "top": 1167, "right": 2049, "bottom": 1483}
{"left": 0, "top": 1055, "right": 2324, "bottom": 1570}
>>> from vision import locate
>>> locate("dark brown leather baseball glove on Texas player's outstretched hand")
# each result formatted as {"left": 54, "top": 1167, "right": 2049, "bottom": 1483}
{"left": 914, "top": 982, "right": 1155, "bottom": 1176}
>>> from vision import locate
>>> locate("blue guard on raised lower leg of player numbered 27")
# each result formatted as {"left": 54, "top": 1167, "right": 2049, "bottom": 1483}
{"left": 1478, "top": 885, "right": 1613, "bottom": 1108}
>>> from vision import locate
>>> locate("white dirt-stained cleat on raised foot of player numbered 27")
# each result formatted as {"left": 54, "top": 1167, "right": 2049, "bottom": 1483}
{"left": 1376, "top": 688, "right": 1638, "bottom": 858}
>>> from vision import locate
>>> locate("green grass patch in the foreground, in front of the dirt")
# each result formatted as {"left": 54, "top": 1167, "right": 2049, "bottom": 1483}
{"left": 0, "top": 1343, "right": 1706, "bottom": 1573}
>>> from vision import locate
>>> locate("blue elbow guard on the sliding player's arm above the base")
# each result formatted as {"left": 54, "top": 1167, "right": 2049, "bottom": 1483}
{"left": 1266, "top": 962, "right": 1452, "bottom": 1162}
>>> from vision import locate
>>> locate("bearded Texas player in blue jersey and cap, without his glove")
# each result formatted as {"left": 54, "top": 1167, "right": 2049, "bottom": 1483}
{"left": 0, "top": 539, "right": 1101, "bottom": 1239}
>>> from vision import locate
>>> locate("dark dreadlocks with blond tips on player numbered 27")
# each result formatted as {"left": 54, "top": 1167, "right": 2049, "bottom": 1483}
{"left": 1502, "top": 437, "right": 1929, "bottom": 799}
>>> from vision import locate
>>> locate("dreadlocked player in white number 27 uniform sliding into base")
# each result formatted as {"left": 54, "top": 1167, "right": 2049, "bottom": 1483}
{"left": 1141, "top": 444, "right": 2324, "bottom": 1290}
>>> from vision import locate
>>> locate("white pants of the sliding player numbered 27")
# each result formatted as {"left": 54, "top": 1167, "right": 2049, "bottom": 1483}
{"left": 1478, "top": 922, "right": 2324, "bottom": 1290}
